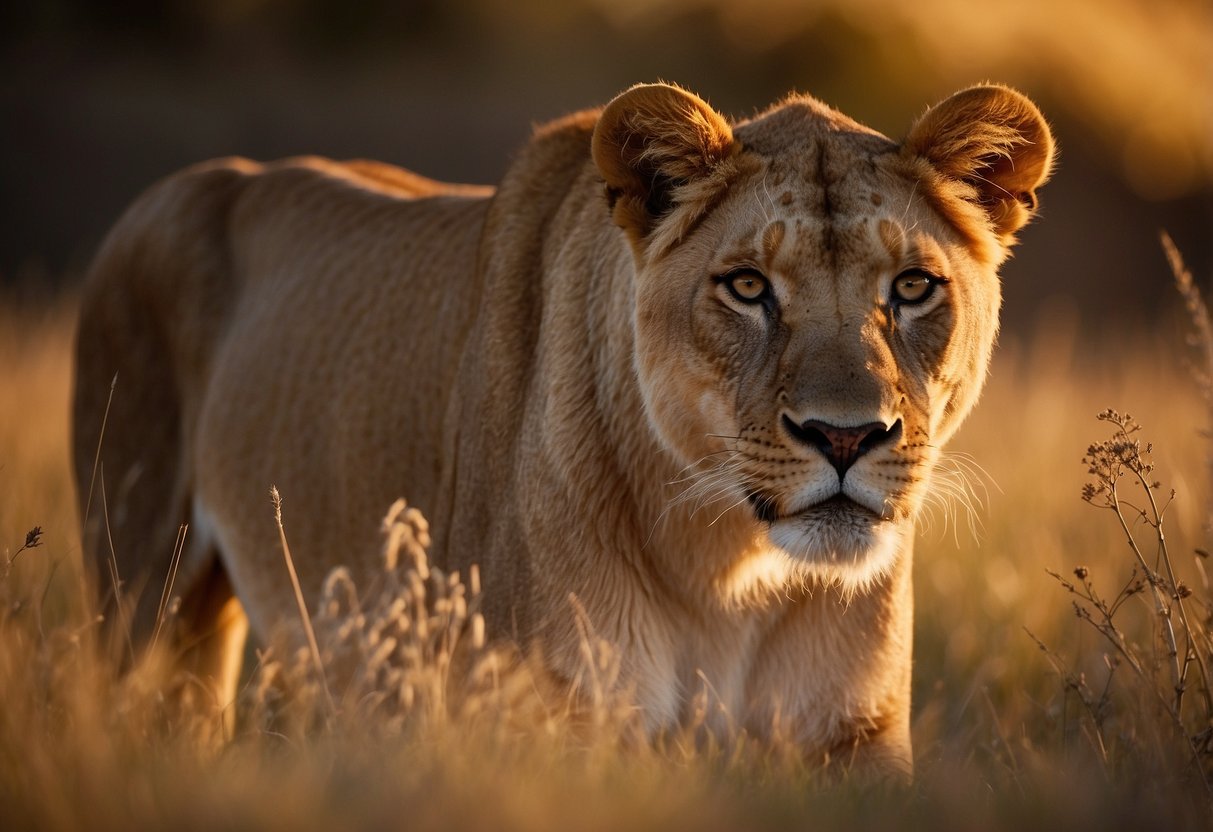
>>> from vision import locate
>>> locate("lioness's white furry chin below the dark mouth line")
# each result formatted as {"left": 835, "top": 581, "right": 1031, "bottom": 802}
{"left": 769, "top": 497, "right": 906, "bottom": 593}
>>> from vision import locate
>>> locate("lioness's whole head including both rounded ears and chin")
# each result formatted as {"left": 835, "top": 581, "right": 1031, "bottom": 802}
{"left": 593, "top": 85, "right": 1053, "bottom": 588}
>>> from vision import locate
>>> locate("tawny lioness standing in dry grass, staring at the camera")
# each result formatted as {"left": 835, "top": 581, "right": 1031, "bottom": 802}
{"left": 74, "top": 84, "right": 1053, "bottom": 773}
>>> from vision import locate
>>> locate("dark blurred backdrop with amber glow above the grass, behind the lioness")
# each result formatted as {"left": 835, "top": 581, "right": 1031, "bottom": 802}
{"left": 0, "top": 0, "right": 1213, "bottom": 331}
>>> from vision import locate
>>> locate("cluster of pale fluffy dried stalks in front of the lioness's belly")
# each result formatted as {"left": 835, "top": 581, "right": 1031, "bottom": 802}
{"left": 251, "top": 500, "right": 519, "bottom": 734}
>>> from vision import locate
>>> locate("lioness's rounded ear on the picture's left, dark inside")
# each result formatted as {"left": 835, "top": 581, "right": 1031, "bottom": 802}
{"left": 592, "top": 84, "right": 736, "bottom": 244}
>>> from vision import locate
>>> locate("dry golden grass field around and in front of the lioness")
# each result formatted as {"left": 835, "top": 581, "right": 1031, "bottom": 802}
{"left": 0, "top": 274, "right": 1211, "bottom": 830}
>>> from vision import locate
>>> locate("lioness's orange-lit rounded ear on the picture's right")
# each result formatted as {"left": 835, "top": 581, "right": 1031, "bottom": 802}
{"left": 901, "top": 85, "right": 1054, "bottom": 243}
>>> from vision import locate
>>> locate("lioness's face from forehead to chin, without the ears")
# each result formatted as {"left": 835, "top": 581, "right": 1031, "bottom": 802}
{"left": 636, "top": 148, "right": 1000, "bottom": 587}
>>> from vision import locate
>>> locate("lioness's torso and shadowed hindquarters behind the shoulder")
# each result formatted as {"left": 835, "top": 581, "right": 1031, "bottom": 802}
{"left": 75, "top": 158, "right": 492, "bottom": 640}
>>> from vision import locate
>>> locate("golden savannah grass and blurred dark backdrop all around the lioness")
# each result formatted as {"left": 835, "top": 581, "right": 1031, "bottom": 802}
{"left": 0, "top": 0, "right": 1213, "bottom": 832}
